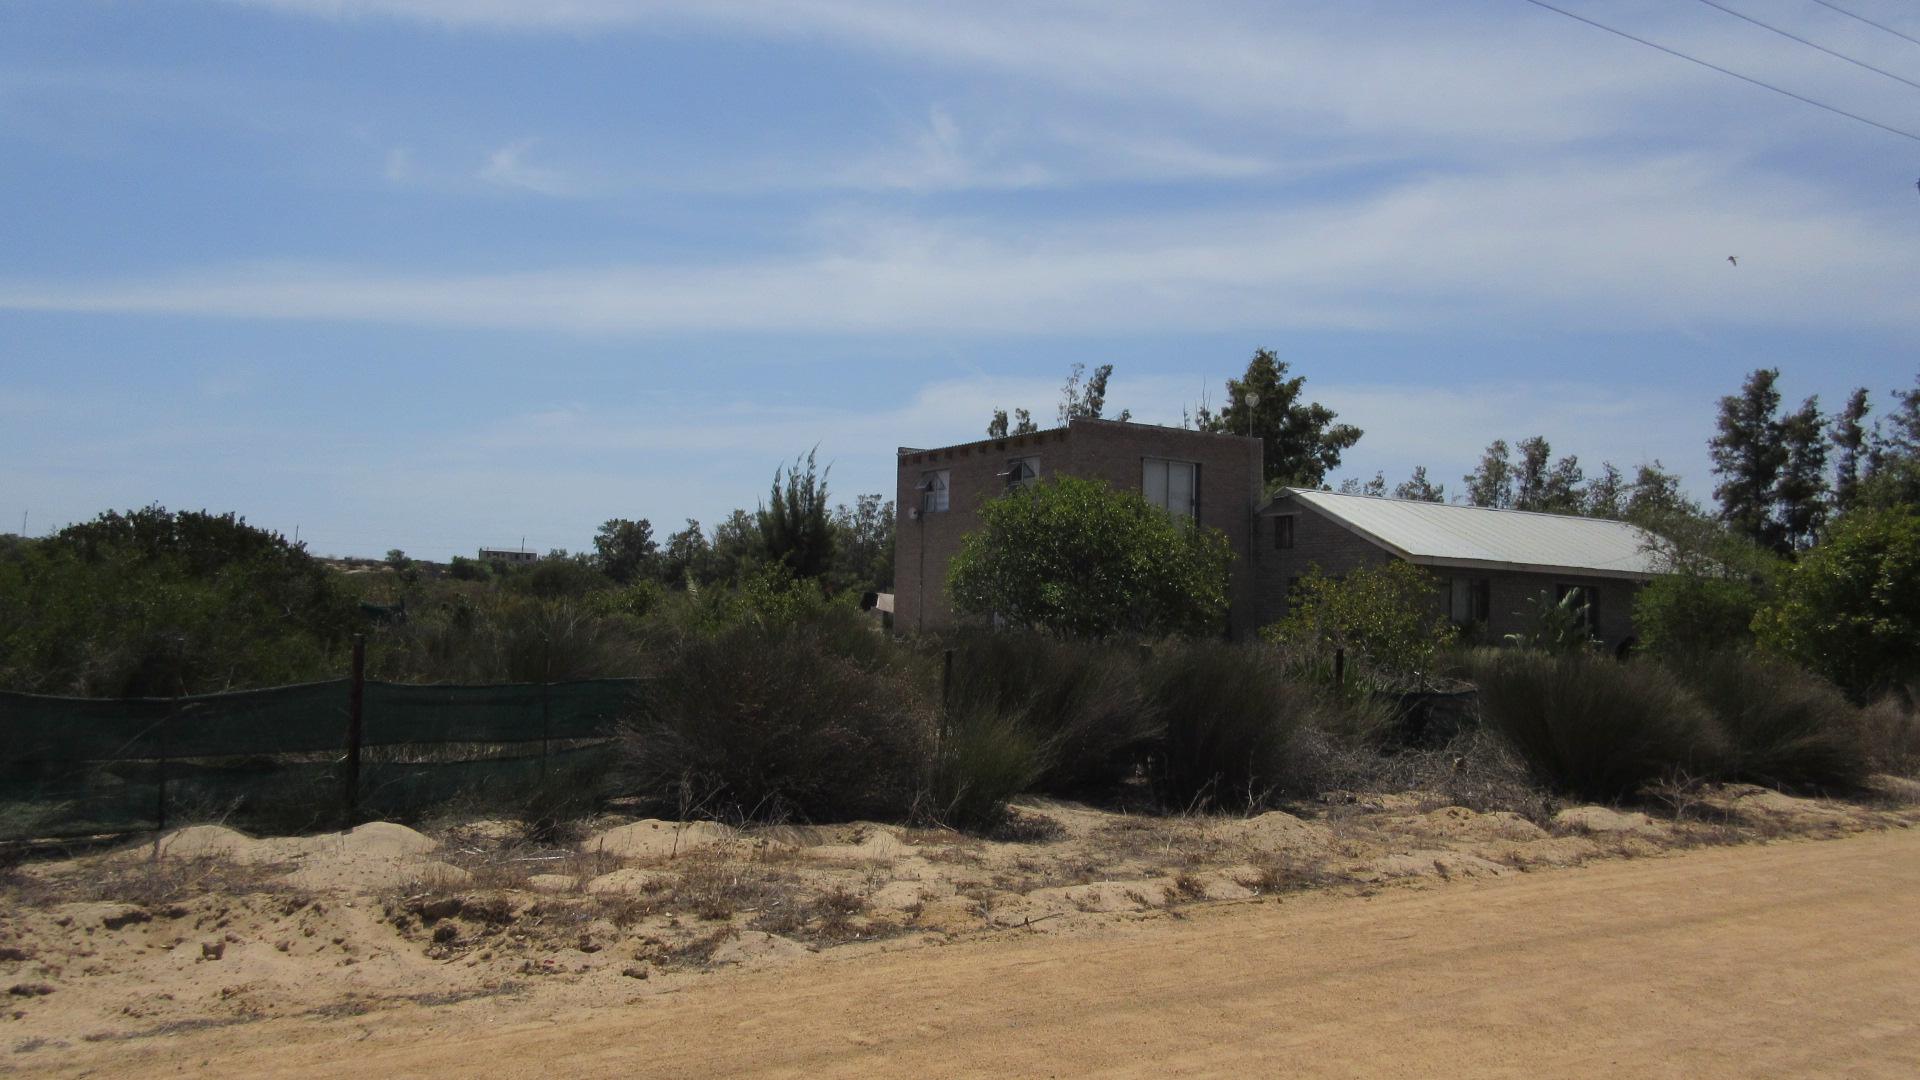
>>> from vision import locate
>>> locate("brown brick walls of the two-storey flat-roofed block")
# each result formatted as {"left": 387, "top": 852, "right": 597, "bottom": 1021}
{"left": 893, "top": 421, "right": 1261, "bottom": 634}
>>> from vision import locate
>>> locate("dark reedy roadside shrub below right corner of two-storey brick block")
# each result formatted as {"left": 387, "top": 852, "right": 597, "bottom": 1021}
{"left": 1146, "top": 642, "right": 1319, "bottom": 809}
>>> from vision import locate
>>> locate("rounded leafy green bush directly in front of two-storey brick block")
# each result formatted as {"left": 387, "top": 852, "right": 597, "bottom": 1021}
{"left": 947, "top": 477, "right": 1233, "bottom": 638}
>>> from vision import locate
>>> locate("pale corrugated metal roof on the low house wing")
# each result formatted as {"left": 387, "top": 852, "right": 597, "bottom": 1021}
{"left": 1269, "top": 488, "right": 1659, "bottom": 578}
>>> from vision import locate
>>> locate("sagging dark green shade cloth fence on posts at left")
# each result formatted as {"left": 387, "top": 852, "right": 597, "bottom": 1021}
{"left": 0, "top": 678, "right": 643, "bottom": 840}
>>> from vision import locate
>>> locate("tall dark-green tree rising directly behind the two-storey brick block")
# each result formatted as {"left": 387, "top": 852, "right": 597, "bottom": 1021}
{"left": 1200, "top": 348, "right": 1361, "bottom": 490}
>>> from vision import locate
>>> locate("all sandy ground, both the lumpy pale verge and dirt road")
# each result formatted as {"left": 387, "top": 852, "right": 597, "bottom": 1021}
{"left": 0, "top": 776, "right": 1920, "bottom": 1076}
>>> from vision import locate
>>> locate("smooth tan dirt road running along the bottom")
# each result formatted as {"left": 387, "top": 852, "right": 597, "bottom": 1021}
{"left": 30, "top": 830, "right": 1920, "bottom": 1078}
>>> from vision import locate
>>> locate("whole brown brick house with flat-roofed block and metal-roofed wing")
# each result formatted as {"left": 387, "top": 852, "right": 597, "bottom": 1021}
{"left": 893, "top": 421, "right": 1657, "bottom": 648}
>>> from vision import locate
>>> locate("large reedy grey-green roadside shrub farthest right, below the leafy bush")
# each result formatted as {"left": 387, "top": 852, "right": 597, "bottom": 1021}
{"left": 1676, "top": 651, "right": 1872, "bottom": 788}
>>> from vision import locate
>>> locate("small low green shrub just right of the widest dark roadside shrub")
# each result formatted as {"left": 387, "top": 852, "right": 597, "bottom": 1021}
{"left": 920, "top": 705, "right": 1048, "bottom": 832}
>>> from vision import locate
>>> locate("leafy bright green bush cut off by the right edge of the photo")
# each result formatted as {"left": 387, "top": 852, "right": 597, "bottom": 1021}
{"left": 1753, "top": 505, "right": 1920, "bottom": 700}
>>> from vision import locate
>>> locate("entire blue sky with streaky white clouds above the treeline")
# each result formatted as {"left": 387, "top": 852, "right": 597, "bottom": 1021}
{"left": 0, "top": 0, "right": 1920, "bottom": 557}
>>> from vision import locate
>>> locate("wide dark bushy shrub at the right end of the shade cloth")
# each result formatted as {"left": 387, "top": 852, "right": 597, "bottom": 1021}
{"left": 624, "top": 625, "right": 933, "bottom": 821}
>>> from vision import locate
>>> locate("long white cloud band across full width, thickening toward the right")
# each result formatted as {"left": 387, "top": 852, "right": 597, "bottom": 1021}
{"left": 0, "top": 146, "right": 1920, "bottom": 332}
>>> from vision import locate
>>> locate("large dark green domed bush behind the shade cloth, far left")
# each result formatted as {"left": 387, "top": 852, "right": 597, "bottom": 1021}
{"left": 0, "top": 505, "right": 359, "bottom": 698}
